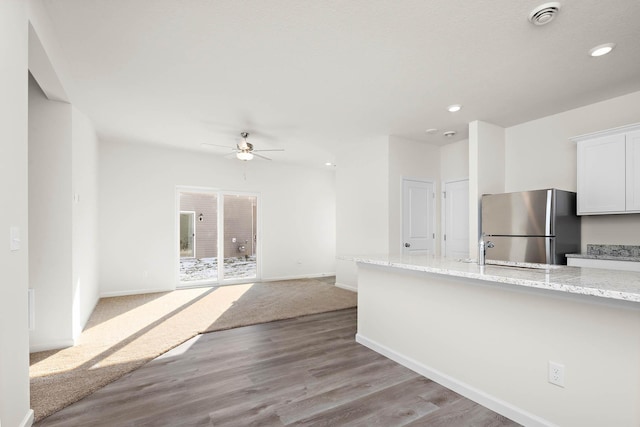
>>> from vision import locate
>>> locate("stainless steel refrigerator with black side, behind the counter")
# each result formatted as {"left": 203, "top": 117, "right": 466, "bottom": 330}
{"left": 482, "top": 188, "right": 580, "bottom": 264}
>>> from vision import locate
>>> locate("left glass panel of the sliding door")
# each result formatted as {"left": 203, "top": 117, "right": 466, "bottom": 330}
{"left": 179, "top": 192, "right": 218, "bottom": 285}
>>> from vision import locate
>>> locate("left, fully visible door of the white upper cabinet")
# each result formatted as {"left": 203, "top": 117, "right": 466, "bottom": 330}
{"left": 577, "top": 134, "right": 626, "bottom": 215}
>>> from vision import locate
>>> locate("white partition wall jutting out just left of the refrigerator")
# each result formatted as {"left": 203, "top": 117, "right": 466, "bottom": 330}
{"left": 469, "top": 121, "right": 505, "bottom": 258}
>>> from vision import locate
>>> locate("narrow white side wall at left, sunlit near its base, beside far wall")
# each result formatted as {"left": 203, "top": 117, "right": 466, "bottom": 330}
{"left": 72, "top": 107, "right": 99, "bottom": 340}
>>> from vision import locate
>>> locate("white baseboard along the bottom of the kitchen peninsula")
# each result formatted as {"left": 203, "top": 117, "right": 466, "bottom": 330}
{"left": 356, "top": 334, "right": 555, "bottom": 427}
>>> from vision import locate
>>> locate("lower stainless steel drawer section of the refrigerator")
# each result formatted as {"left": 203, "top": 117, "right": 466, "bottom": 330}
{"left": 485, "top": 236, "right": 566, "bottom": 264}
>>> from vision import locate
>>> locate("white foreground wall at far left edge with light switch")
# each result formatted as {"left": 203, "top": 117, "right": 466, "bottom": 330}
{"left": 0, "top": 0, "right": 33, "bottom": 427}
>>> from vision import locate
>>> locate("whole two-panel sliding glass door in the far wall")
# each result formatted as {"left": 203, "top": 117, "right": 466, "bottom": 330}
{"left": 177, "top": 189, "right": 258, "bottom": 287}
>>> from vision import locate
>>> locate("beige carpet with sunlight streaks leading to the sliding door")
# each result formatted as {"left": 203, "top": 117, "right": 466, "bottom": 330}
{"left": 30, "top": 278, "right": 357, "bottom": 421}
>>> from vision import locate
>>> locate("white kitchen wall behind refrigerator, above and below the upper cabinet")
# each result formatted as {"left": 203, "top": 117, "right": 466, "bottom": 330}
{"left": 505, "top": 92, "right": 640, "bottom": 251}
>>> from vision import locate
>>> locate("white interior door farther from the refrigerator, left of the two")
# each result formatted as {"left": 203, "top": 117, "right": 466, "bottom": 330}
{"left": 402, "top": 179, "right": 435, "bottom": 254}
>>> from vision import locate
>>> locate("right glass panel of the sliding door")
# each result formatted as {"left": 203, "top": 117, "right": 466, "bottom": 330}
{"left": 222, "top": 194, "right": 257, "bottom": 280}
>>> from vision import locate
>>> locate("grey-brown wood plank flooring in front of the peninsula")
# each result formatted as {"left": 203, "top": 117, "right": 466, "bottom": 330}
{"left": 36, "top": 309, "right": 518, "bottom": 427}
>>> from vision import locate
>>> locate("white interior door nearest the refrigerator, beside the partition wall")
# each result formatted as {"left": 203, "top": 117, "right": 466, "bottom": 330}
{"left": 442, "top": 179, "right": 469, "bottom": 258}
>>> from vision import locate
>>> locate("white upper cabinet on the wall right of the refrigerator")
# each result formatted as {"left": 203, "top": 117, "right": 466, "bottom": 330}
{"left": 572, "top": 124, "right": 640, "bottom": 215}
